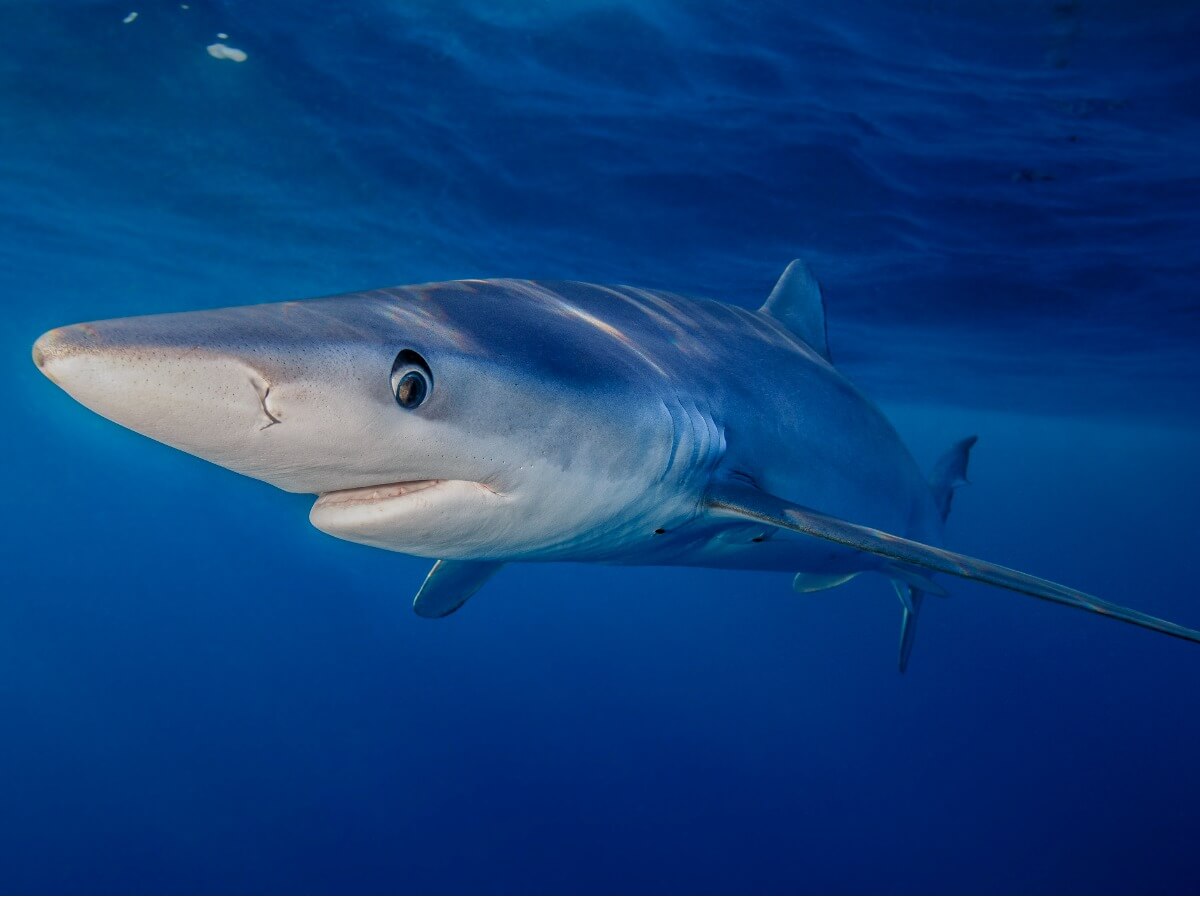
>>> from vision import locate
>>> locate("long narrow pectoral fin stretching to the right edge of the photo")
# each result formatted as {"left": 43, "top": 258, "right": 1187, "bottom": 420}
{"left": 708, "top": 485, "right": 1200, "bottom": 643}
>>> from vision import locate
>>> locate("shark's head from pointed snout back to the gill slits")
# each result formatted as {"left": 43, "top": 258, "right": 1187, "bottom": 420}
{"left": 34, "top": 282, "right": 696, "bottom": 559}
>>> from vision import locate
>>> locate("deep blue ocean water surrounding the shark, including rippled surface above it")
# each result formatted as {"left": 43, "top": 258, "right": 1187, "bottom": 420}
{"left": 0, "top": 0, "right": 1200, "bottom": 893}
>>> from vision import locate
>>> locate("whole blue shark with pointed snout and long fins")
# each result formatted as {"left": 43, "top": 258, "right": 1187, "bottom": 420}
{"left": 32, "top": 260, "right": 1200, "bottom": 672}
